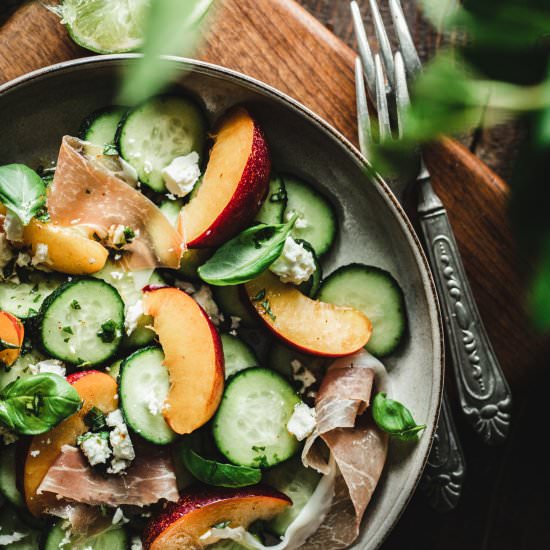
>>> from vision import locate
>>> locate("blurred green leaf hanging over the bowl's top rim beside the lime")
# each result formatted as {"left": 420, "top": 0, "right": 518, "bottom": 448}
{"left": 118, "top": 0, "right": 214, "bottom": 105}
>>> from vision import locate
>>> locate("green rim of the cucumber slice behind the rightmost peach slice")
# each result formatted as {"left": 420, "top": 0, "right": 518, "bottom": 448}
{"left": 318, "top": 263, "right": 408, "bottom": 357}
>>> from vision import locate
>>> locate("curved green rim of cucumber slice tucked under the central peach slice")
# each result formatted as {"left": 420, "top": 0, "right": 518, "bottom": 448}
{"left": 118, "top": 346, "right": 177, "bottom": 445}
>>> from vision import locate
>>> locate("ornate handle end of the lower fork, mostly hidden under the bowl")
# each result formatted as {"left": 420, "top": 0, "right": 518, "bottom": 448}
{"left": 421, "top": 393, "right": 466, "bottom": 512}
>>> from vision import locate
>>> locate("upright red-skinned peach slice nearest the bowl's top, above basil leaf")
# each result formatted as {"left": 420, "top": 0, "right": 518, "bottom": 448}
{"left": 178, "top": 107, "right": 271, "bottom": 248}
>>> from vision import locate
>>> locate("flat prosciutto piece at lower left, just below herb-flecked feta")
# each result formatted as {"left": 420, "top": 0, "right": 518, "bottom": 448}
{"left": 38, "top": 445, "right": 179, "bottom": 507}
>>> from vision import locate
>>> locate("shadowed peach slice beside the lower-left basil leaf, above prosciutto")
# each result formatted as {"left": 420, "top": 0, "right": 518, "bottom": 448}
{"left": 24, "top": 370, "right": 118, "bottom": 516}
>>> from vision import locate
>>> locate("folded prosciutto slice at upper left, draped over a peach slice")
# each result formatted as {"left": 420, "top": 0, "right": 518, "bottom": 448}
{"left": 48, "top": 136, "right": 184, "bottom": 270}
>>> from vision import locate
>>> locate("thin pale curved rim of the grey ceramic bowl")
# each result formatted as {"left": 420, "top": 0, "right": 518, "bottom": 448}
{"left": 0, "top": 53, "right": 445, "bottom": 550}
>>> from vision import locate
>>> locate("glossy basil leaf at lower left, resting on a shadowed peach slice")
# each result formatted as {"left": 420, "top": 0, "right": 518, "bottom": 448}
{"left": 0, "top": 373, "right": 81, "bottom": 435}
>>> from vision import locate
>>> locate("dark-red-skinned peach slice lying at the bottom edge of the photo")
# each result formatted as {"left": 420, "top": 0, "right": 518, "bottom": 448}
{"left": 143, "top": 485, "right": 292, "bottom": 550}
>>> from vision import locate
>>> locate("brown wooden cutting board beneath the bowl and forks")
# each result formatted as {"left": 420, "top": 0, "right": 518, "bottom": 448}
{"left": 0, "top": 0, "right": 545, "bottom": 391}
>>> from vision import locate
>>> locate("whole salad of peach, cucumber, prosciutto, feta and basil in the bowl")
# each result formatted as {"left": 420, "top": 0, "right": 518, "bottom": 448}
{"left": 0, "top": 95, "right": 424, "bottom": 550}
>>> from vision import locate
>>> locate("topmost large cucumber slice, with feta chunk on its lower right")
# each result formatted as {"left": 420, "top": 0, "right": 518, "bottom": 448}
{"left": 117, "top": 96, "right": 206, "bottom": 192}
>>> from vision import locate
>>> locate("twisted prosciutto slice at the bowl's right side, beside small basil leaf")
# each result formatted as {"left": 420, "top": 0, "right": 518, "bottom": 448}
{"left": 302, "top": 351, "right": 388, "bottom": 550}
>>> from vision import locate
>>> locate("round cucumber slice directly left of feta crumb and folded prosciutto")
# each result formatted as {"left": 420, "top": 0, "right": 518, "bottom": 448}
{"left": 212, "top": 367, "right": 301, "bottom": 468}
